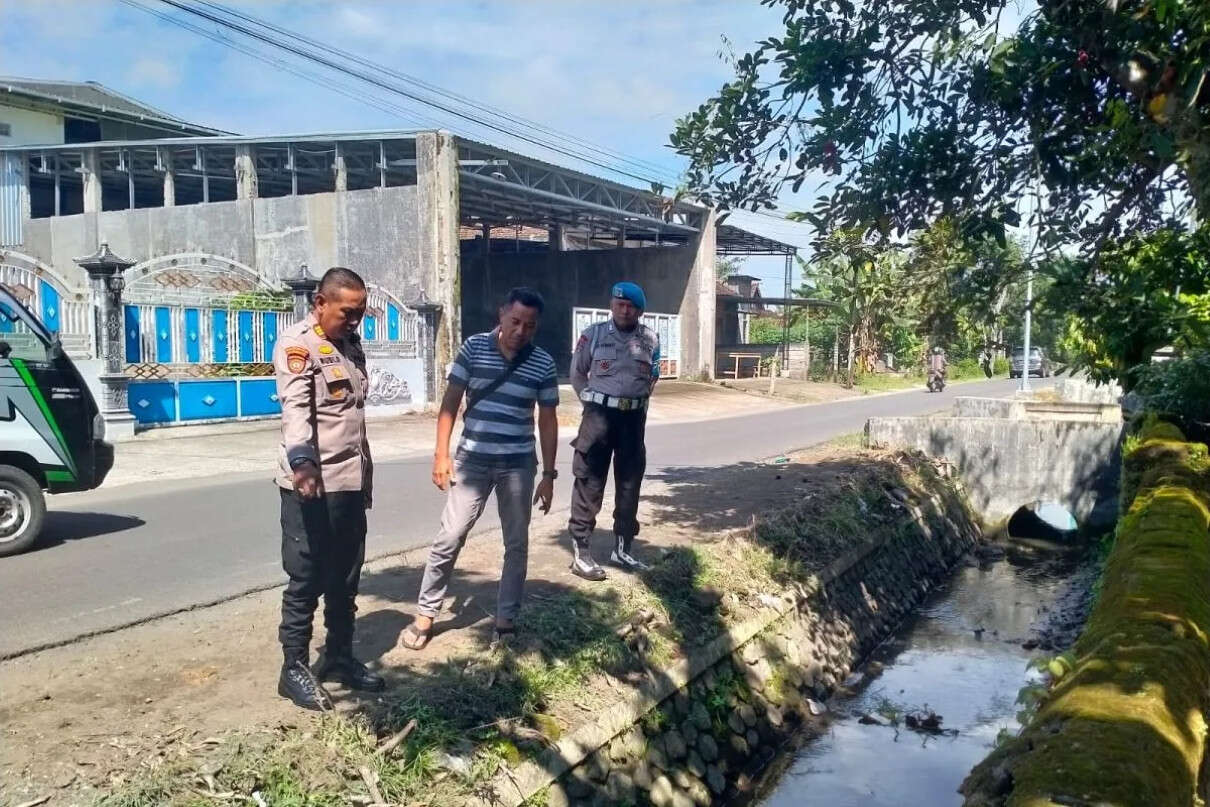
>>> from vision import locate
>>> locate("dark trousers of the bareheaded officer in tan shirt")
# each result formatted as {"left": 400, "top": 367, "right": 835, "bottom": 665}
{"left": 277, "top": 488, "right": 365, "bottom": 661}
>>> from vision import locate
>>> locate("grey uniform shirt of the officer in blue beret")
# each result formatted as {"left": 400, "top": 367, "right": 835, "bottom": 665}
{"left": 571, "top": 319, "right": 659, "bottom": 398}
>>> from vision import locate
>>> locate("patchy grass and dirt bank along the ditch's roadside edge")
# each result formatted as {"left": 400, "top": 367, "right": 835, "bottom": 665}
{"left": 99, "top": 448, "right": 951, "bottom": 807}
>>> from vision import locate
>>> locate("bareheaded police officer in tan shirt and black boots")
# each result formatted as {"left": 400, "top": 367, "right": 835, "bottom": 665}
{"left": 273, "top": 267, "right": 385, "bottom": 710}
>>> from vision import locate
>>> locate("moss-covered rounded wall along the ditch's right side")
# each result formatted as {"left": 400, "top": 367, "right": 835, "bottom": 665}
{"left": 962, "top": 421, "right": 1210, "bottom": 807}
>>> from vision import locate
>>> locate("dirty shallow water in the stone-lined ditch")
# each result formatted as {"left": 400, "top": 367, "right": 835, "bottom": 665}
{"left": 745, "top": 541, "right": 1095, "bottom": 807}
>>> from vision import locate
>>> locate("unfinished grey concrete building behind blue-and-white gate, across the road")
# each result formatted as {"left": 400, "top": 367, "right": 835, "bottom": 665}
{"left": 0, "top": 88, "right": 793, "bottom": 426}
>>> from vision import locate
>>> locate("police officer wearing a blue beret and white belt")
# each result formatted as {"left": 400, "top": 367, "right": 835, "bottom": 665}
{"left": 567, "top": 283, "right": 659, "bottom": 581}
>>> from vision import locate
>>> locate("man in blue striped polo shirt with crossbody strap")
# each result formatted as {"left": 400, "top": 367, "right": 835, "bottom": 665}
{"left": 401, "top": 288, "right": 559, "bottom": 650}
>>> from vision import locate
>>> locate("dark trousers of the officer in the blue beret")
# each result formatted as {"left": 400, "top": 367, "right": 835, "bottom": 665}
{"left": 567, "top": 403, "right": 647, "bottom": 543}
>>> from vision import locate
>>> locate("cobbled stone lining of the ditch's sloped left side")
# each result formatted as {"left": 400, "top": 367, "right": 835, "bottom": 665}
{"left": 491, "top": 469, "right": 981, "bottom": 807}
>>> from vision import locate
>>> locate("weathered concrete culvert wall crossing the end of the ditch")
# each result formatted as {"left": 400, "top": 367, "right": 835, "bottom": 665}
{"left": 866, "top": 398, "right": 1122, "bottom": 529}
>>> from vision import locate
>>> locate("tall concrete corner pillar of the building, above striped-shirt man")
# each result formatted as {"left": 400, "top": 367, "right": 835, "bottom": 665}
{"left": 416, "top": 132, "right": 462, "bottom": 390}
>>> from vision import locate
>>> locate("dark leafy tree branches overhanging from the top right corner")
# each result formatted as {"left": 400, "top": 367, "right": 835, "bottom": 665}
{"left": 672, "top": 0, "right": 1210, "bottom": 246}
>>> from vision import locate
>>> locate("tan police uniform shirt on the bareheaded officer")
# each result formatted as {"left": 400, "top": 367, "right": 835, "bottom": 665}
{"left": 273, "top": 315, "right": 374, "bottom": 492}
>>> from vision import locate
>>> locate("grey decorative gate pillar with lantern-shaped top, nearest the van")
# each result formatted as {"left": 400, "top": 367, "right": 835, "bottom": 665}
{"left": 75, "top": 242, "right": 136, "bottom": 443}
